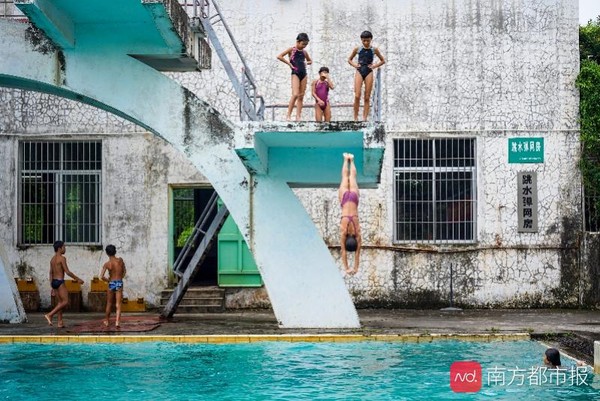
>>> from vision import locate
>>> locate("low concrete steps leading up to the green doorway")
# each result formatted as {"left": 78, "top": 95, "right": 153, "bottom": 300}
{"left": 160, "top": 286, "right": 225, "bottom": 315}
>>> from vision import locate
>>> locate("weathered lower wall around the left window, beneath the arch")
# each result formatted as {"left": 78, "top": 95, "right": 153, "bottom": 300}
{"left": 0, "top": 112, "right": 205, "bottom": 307}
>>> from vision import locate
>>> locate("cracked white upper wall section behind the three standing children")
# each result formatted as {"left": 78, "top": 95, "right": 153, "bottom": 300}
{"left": 174, "top": 0, "right": 579, "bottom": 131}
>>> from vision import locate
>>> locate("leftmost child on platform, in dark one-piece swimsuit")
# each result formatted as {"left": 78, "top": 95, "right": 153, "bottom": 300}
{"left": 277, "top": 33, "right": 312, "bottom": 121}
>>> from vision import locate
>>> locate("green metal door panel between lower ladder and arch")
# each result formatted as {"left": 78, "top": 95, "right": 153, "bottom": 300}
{"left": 217, "top": 205, "right": 263, "bottom": 287}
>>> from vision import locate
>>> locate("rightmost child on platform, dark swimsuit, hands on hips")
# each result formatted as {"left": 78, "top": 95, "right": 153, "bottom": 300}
{"left": 348, "top": 31, "right": 385, "bottom": 121}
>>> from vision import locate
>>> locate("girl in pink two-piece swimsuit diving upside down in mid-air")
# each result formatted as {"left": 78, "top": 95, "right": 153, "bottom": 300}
{"left": 338, "top": 153, "right": 362, "bottom": 274}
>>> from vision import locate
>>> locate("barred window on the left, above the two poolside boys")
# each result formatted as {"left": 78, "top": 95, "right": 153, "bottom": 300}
{"left": 19, "top": 141, "right": 102, "bottom": 245}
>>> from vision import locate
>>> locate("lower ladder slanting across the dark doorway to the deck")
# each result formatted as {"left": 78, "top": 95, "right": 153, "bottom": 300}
{"left": 161, "top": 192, "right": 229, "bottom": 318}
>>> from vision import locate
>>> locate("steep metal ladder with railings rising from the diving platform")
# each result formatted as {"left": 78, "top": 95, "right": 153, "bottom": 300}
{"left": 180, "top": 0, "right": 265, "bottom": 121}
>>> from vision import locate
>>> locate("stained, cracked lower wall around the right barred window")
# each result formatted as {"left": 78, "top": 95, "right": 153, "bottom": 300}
{"left": 297, "top": 131, "right": 580, "bottom": 307}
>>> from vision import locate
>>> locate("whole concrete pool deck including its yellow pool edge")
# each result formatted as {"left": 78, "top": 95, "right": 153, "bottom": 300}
{"left": 0, "top": 309, "right": 600, "bottom": 373}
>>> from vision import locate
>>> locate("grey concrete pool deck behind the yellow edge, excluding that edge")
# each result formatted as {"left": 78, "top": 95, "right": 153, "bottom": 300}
{"left": 0, "top": 309, "right": 600, "bottom": 340}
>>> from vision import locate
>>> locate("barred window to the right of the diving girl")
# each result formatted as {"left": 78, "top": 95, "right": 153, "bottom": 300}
{"left": 394, "top": 138, "right": 477, "bottom": 243}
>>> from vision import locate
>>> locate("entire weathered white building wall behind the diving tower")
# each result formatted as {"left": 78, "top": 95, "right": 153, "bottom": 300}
{"left": 0, "top": 0, "right": 593, "bottom": 307}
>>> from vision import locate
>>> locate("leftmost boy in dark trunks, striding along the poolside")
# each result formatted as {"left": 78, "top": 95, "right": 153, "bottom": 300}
{"left": 44, "top": 241, "right": 83, "bottom": 329}
